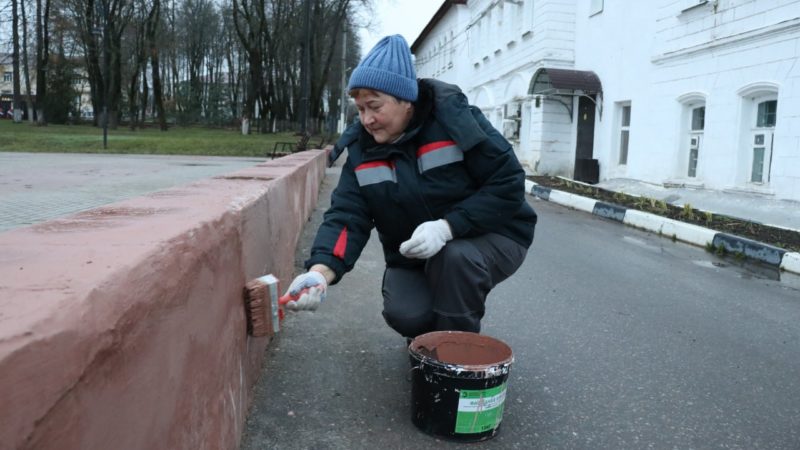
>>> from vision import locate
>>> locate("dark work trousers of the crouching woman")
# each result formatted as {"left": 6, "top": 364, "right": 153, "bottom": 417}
{"left": 383, "top": 233, "right": 527, "bottom": 338}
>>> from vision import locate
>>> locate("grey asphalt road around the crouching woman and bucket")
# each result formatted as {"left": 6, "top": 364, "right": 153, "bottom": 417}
{"left": 242, "top": 168, "right": 800, "bottom": 450}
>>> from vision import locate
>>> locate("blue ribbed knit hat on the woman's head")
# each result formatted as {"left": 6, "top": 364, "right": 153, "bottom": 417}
{"left": 347, "top": 34, "right": 419, "bottom": 102}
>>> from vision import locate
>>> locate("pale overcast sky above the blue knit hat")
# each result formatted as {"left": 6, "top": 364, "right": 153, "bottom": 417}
{"left": 360, "top": 0, "right": 443, "bottom": 56}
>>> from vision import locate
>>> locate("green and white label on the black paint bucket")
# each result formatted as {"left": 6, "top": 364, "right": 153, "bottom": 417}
{"left": 455, "top": 383, "right": 506, "bottom": 434}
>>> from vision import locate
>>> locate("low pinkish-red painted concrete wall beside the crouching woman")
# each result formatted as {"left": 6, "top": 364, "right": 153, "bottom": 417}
{"left": 0, "top": 150, "right": 326, "bottom": 449}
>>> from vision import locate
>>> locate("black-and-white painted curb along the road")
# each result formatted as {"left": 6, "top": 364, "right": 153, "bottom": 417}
{"left": 525, "top": 180, "right": 800, "bottom": 274}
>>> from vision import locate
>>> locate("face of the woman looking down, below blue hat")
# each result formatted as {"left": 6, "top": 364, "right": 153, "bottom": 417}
{"left": 353, "top": 89, "right": 414, "bottom": 144}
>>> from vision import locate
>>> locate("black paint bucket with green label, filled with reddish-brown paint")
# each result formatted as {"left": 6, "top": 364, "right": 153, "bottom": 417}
{"left": 408, "top": 331, "right": 514, "bottom": 442}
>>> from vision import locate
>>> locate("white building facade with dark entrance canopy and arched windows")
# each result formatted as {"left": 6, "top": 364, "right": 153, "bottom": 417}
{"left": 412, "top": 0, "right": 800, "bottom": 200}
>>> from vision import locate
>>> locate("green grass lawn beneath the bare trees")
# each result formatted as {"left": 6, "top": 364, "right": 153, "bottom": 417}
{"left": 0, "top": 120, "right": 328, "bottom": 157}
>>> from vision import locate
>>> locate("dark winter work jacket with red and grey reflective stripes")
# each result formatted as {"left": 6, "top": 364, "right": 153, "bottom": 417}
{"left": 305, "top": 79, "right": 536, "bottom": 282}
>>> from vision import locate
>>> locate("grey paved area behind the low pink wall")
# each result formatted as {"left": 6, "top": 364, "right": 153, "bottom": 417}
{"left": 0, "top": 152, "right": 264, "bottom": 232}
